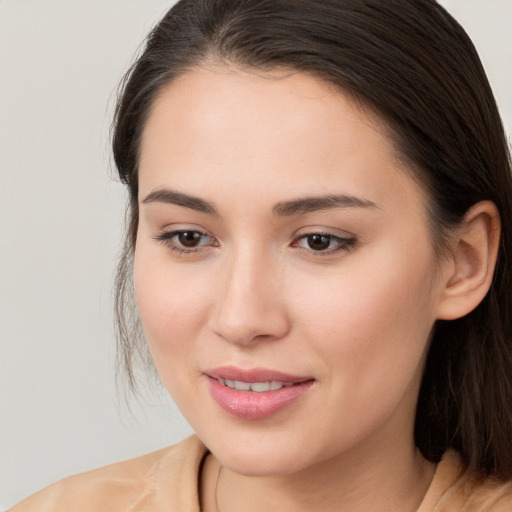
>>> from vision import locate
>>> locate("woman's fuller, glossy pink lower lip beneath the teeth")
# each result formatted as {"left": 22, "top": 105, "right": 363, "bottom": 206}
{"left": 208, "top": 377, "right": 314, "bottom": 420}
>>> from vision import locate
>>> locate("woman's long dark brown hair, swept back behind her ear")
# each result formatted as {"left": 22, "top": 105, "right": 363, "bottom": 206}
{"left": 113, "top": 0, "right": 512, "bottom": 479}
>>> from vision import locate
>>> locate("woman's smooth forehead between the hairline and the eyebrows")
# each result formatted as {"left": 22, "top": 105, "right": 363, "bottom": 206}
{"left": 139, "top": 66, "right": 424, "bottom": 213}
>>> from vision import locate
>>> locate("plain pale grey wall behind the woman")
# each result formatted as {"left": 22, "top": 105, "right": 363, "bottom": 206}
{"left": 0, "top": 0, "right": 512, "bottom": 511}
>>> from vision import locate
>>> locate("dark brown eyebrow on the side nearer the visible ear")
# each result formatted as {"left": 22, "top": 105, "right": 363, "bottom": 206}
{"left": 272, "top": 194, "right": 378, "bottom": 217}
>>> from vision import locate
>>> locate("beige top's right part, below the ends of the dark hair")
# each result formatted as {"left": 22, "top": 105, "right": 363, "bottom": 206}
{"left": 418, "top": 451, "right": 512, "bottom": 512}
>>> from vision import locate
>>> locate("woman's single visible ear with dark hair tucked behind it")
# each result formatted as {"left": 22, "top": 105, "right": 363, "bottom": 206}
{"left": 437, "top": 201, "right": 501, "bottom": 320}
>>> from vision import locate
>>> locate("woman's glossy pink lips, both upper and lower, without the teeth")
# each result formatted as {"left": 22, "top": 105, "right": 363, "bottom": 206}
{"left": 204, "top": 366, "right": 314, "bottom": 420}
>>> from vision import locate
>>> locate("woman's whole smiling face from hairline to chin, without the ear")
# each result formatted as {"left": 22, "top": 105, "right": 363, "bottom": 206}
{"left": 135, "top": 66, "right": 448, "bottom": 475}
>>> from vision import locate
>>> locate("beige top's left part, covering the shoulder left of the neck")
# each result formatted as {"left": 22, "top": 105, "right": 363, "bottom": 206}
{"left": 10, "top": 436, "right": 207, "bottom": 512}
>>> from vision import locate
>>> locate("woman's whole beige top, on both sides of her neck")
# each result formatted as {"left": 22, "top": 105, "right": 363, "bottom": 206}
{"left": 10, "top": 436, "right": 512, "bottom": 512}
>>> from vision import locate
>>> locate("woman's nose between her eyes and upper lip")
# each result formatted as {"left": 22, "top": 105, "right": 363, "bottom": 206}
{"left": 210, "top": 252, "right": 290, "bottom": 346}
